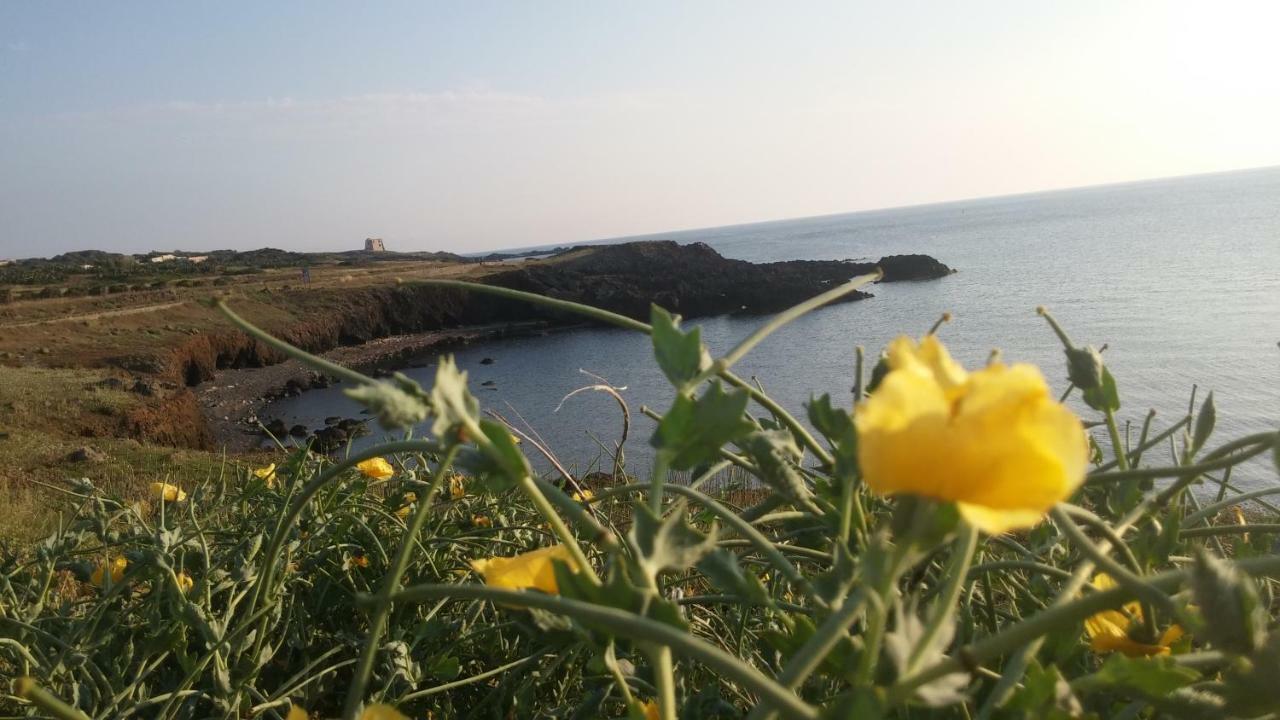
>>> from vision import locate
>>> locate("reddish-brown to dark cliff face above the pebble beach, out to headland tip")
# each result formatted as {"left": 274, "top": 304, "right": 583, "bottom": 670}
{"left": 114, "top": 241, "right": 952, "bottom": 447}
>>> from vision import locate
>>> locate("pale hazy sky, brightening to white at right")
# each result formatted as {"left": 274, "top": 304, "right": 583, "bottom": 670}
{"left": 0, "top": 0, "right": 1280, "bottom": 258}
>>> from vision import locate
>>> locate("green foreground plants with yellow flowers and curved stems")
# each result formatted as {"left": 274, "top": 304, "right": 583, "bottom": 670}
{"left": 0, "top": 269, "right": 1280, "bottom": 720}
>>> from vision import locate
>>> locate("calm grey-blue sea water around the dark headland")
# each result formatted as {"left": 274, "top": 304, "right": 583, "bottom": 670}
{"left": 274, "top": 168, "right": 1280, "bottom": 486}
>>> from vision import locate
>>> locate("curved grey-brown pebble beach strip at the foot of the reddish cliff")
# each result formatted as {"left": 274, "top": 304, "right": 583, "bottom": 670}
{"left": 191, "top": 320, "right": 558, "bottom": 452}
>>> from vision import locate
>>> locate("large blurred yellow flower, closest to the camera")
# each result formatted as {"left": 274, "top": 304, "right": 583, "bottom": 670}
{"left": 854, "top": 336, "right": 1088, "bottom": 533}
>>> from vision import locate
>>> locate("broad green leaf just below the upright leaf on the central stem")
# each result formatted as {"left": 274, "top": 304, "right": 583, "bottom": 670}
{"left": 649, "top": 382, "right": 753, "bottom": 470}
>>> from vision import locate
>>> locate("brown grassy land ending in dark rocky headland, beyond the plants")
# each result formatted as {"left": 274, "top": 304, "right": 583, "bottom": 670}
{"left": 0, "top": 241, "right": 954, "bottom": 538}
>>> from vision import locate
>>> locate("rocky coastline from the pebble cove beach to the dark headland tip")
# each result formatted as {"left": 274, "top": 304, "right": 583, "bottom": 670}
{"left": 186, "top": 241, "right": 954, "bottom": 451}
